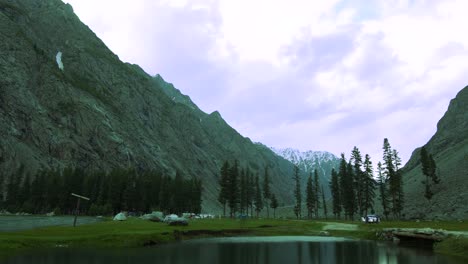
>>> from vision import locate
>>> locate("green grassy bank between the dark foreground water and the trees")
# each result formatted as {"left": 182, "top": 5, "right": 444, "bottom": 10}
{"left": 0, "top": 218, "right": 468, "bottom": 259}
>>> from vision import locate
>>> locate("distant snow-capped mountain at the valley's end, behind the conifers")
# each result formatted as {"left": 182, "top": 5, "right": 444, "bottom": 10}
{"left": 271, "top": 148, "right": 340, "bottom": 196}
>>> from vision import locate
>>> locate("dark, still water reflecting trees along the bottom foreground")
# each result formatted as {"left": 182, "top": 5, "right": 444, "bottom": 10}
{"left": 4, "top": 237, "right": 463, "bottom": 264}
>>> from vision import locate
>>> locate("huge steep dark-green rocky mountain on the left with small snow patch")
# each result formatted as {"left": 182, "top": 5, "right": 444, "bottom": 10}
{"left": 0, "top": 0, "right": 293, "bottom": 212}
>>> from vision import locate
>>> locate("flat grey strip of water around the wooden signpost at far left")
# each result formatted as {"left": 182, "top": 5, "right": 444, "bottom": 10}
{"left": 0, "top": 215, "right": 101, "bottom": 232}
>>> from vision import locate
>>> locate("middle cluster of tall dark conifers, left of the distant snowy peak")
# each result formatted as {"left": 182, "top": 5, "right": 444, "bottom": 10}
{"left": 218, "top": 160, "right": 278, "bottom": 218}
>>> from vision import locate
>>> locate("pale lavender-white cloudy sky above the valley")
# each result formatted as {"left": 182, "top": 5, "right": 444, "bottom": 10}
{"left": 63, "top": 0, "right": 468, "bottom": 164}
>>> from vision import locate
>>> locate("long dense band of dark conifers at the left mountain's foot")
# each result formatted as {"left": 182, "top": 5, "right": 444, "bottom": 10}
{"left": 0, "top": 166, "right": 202, "bottom": 215}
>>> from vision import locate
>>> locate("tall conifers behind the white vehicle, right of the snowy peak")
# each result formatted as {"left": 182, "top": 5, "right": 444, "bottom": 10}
{"left": 330, "top": 138, "right": 404, "bottom": 220}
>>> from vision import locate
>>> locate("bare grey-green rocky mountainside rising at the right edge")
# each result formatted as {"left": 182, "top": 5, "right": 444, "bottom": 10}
{"left": 403, "top": 86, "right": 468, "bottom": 219}
